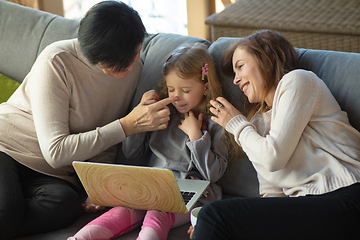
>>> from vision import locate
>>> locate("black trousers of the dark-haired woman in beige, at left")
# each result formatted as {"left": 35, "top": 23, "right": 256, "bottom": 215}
{"left": 0, "top": 152, "right": 83, "bottom": 240}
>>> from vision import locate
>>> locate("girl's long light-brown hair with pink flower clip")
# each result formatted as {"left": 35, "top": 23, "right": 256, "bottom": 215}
{"left": 159, "top": 43, "right": 222, "bottom": 115}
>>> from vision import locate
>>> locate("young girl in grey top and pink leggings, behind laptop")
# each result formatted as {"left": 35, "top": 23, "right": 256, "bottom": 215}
{"left": 69, "top": 44, "right": 228, "bottom": 240}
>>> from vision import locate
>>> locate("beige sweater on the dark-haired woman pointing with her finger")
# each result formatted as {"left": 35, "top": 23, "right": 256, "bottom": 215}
{"left": 0, "top": 39, "right": 142, "bottom": 184}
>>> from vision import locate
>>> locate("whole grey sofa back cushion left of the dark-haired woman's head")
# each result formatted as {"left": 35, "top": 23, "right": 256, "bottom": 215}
{"left": 0, "top": 1, "right": 79, "bottom": 82}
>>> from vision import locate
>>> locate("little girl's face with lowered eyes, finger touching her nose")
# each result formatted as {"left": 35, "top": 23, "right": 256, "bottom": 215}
{"left": 165, "top": 71, "right": 208, "bottom": 114}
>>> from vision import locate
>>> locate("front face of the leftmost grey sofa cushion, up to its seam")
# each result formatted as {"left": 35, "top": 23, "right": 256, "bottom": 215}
{"left": 0, "top": 1, "right": 54, "bottom": 82}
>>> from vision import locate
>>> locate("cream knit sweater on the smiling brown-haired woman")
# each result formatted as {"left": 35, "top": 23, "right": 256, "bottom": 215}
{"left": 226, "top": 70, "right": 360, "bottom": 196}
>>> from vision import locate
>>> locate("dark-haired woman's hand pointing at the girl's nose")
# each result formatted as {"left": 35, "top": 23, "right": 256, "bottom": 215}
{"left": 120, "top": 90, "right": 173, "bottom": 137}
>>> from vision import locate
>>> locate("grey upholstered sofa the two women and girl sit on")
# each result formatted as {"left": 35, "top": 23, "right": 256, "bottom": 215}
{"left": 0, "top": 0, "right": 360, "bottom": 240}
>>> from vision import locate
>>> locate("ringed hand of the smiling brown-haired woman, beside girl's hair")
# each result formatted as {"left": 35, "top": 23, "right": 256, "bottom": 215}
{"left": 210, "top": 97, "right": 241, "bottom": 128}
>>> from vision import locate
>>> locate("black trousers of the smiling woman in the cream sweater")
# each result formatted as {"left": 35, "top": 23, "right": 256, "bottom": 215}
{"left": 192, "top": 183, "right": 360, "bottom": 240}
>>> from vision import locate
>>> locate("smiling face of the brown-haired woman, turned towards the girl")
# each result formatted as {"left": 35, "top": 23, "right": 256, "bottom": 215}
{"left": 233, "top": 48, "right": 265, "bottom": 103}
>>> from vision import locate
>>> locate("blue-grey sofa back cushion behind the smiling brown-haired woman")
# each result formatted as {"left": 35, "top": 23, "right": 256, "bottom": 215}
{"left": 209, "top": 37, "right": 360, "bottom": 197}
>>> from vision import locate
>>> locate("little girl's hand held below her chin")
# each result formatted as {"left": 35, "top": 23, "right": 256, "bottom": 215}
{"left": 178, "top": 111, "right": 204, "bottom": 141}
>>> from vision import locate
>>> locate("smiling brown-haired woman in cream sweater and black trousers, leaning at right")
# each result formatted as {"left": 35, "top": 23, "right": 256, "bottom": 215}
{"left": 193, "top": 31, "right": 360, "bottom": 240}
